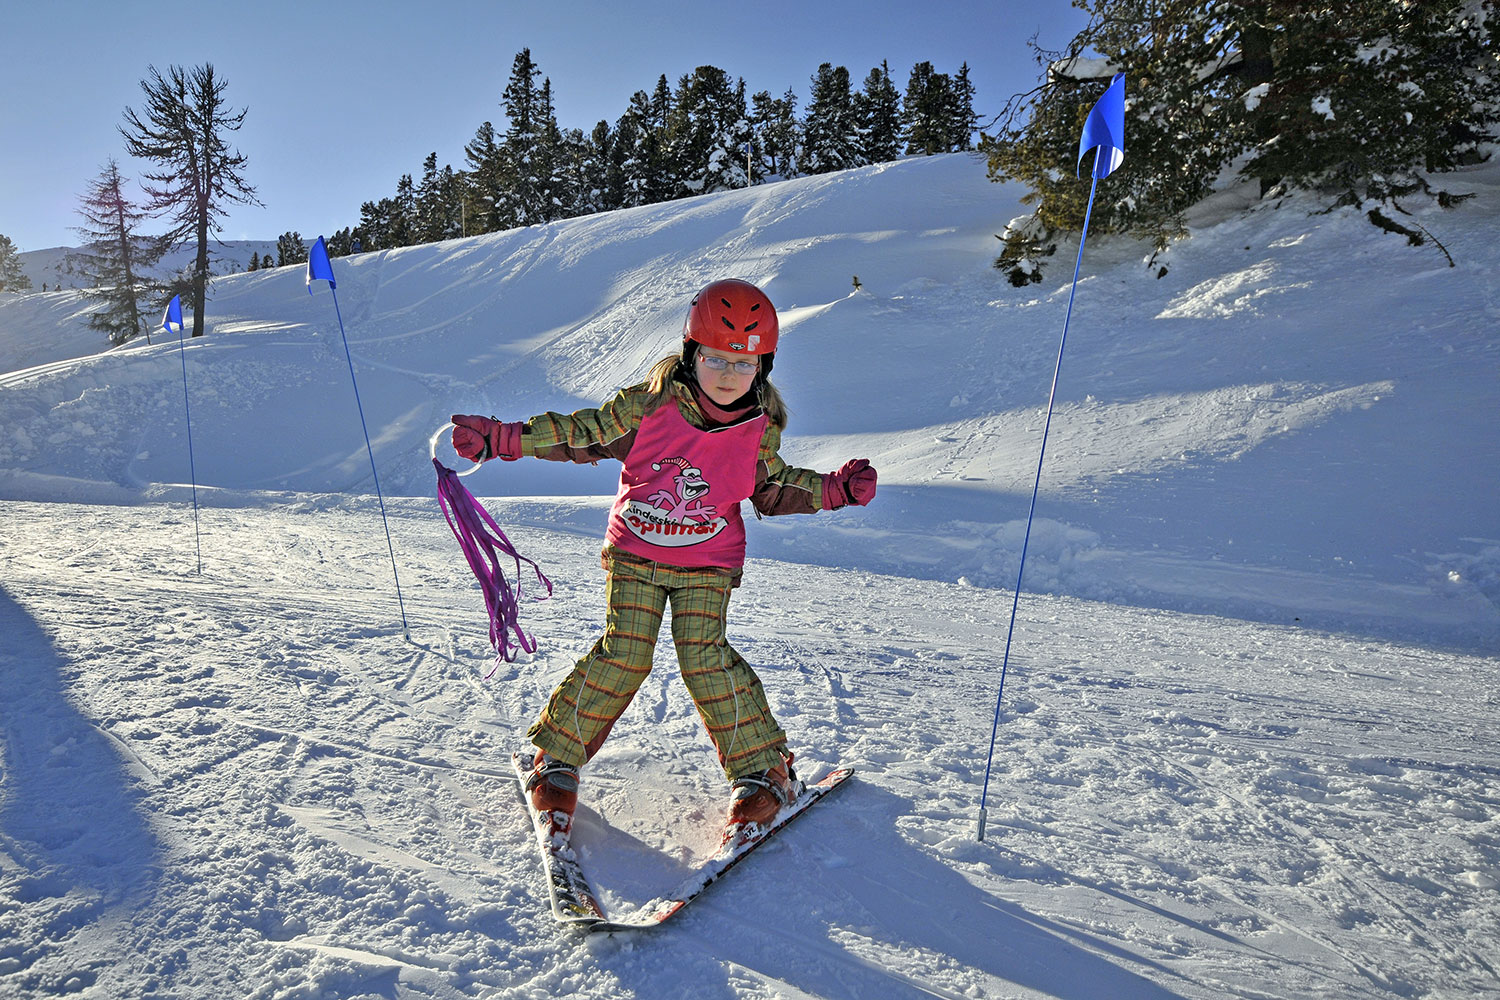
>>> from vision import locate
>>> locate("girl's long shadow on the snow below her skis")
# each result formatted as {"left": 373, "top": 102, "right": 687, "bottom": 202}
{"left": 585, "top": 777, "right": 1179, "bottom": 1000}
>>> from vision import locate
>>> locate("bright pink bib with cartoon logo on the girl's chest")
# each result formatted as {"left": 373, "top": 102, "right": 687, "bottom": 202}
{"left": 605, "top": 402, "right": 767, "bottom": 570}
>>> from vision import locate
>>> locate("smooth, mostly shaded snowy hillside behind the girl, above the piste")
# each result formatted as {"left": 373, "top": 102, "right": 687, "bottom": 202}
{"left": 0, "top": 156, "right": 1500, "bottom": 639}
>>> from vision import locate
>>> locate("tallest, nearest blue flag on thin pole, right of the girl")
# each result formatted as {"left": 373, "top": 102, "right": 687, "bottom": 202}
{"left": 975, "top": 73, "right": 1125, "bottom": 841}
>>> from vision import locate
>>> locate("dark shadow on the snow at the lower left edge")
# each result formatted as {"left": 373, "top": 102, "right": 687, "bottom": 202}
{"left": 0, "top": 589, "right": 159, "bottom": 993}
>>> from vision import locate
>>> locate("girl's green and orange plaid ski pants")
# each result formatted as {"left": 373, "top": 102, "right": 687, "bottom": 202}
{"left": 528, "top": 549, "right": 786, "bottom": 780}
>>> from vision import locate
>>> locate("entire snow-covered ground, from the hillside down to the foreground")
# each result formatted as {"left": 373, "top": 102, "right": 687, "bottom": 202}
{"left": 0, "top": 154, "right": 1500, "bottom": 1000}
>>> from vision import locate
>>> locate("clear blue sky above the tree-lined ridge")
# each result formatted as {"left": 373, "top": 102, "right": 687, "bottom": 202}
{"left": 0, "top": 0, "right": 1083, "bottom": 252}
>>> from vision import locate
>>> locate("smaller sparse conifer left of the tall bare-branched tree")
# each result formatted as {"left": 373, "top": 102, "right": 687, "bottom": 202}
{"left": 72, "top": 159, "right": 167, "bottom": 343}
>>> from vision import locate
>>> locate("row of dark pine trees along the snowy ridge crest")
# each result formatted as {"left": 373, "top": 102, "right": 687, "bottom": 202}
{"left": 334, "top": 49, "right": 996, "bottom": 235}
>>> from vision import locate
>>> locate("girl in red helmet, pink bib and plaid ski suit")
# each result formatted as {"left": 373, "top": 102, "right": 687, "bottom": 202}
{"left": 453, "top": 279, "right": 876, "bottom": 832}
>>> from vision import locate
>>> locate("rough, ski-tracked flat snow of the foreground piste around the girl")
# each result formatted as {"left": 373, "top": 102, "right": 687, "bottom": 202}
{"left": 0, "top": 499, "right": 1500, "bottom": 997}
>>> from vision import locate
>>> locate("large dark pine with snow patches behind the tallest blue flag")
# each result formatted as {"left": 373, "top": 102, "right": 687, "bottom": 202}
{"left": 981, "top": 0, "right": 1500, "bottom": 282}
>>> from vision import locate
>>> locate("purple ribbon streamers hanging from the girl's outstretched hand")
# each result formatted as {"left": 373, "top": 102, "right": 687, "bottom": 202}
{"left": 432, "top": 459, "right": 552, "bottom": 679}
